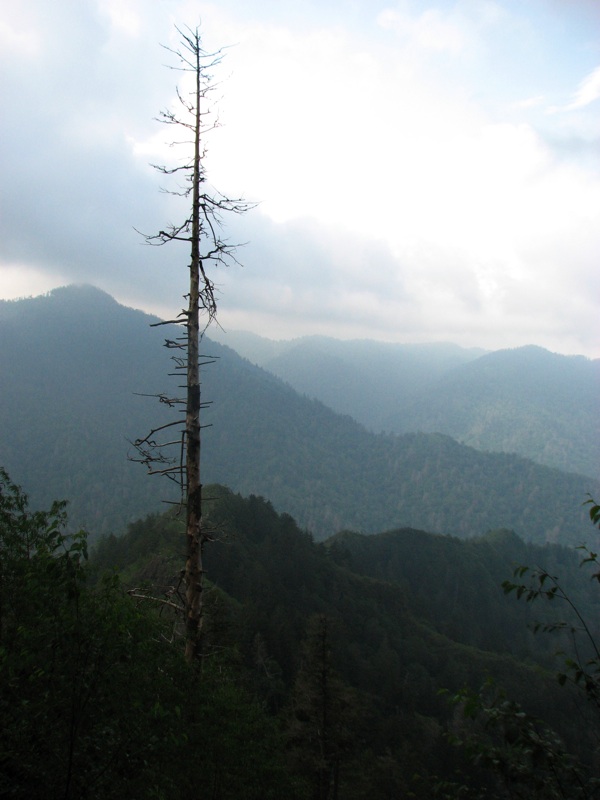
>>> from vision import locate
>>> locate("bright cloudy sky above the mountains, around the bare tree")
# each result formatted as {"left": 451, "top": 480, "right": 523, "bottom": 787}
{"left": 0, "top": 0, "right": 600, "bottom": 358}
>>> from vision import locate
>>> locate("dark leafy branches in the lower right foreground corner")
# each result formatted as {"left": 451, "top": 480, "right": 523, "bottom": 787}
{"left": 445, "top": 497, "right": 600, "bottom": 800}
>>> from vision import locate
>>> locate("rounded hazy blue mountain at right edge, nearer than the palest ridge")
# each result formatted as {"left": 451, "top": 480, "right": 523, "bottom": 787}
{"left": 392, "top": 346, "right": 600, "bottom": 477}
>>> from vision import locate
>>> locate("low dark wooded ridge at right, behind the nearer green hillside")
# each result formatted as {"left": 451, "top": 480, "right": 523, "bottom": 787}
{"left": 326, "top": 528, "right": 600, "bottom": 665}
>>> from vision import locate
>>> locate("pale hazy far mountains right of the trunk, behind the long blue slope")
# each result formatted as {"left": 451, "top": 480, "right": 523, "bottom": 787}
{"left": 212, "top": 331, "right": 600, "bottom": 478}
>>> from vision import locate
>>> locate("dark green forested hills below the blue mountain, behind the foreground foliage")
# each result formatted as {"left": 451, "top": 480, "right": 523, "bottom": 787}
{"left": 94, "top": 486, "right": 598, "bottom": 800}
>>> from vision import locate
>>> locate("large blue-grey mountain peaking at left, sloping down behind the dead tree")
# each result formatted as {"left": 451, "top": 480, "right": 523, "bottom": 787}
{"left": 0, "top": 287, "right": 600, "bottom": 543}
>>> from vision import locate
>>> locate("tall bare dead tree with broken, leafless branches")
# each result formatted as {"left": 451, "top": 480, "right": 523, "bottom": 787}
{"left": 133, "top": 28, "right": 250, "bottom": 664}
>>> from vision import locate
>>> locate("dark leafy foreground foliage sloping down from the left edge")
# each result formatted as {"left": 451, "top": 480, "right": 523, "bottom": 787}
{"left": 0, "top": 470, "right": 291, "bottom": 800}
